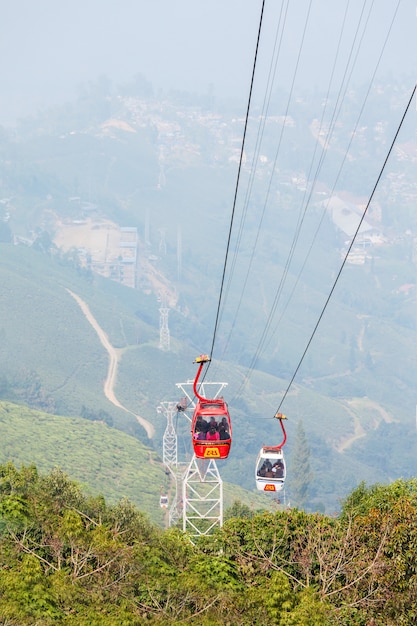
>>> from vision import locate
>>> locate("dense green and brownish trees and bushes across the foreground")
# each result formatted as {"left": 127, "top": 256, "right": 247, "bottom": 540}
{"left": 0, "top": 464, "right": 417, "bottom": 626}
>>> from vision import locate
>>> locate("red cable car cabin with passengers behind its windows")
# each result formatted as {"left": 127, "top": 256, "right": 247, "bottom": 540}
{"left": 191, "top": 398, "right": 232, "bottom": 459}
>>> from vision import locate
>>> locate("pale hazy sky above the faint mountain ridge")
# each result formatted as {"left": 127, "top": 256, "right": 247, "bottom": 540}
{"left": 0, "top": 0, "right": 417, "bottom": 124}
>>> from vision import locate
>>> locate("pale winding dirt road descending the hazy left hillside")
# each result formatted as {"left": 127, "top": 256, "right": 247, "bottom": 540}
{"left": 67, "top": 289, "right": 155, "bottom": 439}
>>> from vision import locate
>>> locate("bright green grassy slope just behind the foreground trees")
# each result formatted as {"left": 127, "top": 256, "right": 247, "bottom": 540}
{"left": 0, "top": 402, "right": 274, "bottom": 526}
